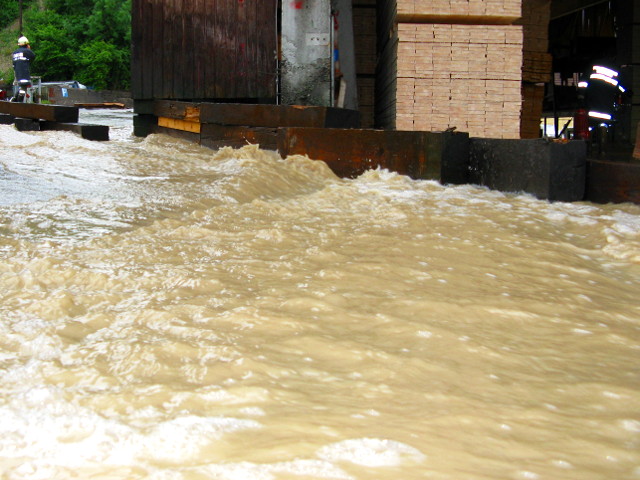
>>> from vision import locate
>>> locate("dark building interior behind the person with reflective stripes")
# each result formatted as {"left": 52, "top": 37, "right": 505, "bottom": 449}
{"left": 543, "top": 0, "right": 640, "bottom": 158}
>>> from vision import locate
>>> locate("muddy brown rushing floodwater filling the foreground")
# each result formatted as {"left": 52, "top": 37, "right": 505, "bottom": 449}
{"left": 0, "top": 111, "right": 640, "bottom": 480}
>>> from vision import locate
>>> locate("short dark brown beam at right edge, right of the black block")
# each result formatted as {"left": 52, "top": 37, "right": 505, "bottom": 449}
{"left": 585, "top": 160, "right": 640, "bottom": 204}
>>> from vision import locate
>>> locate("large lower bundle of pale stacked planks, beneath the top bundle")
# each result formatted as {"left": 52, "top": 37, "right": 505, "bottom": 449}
{"left": 396, "top": 23, "right": 522, "bottom": 138}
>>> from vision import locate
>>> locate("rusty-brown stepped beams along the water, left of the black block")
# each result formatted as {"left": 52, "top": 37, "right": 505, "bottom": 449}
{"left": 141, "top": 100, "right": 469, "bottom": 184}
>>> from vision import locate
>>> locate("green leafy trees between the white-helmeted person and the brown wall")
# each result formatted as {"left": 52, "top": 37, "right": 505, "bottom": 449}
{"left": 19, "top": 0, "right": 131, "bottom": 89}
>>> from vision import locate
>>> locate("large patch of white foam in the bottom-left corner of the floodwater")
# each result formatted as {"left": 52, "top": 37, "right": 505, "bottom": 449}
{"left": 0, "top": 385, "right": 261, "bottom": 479}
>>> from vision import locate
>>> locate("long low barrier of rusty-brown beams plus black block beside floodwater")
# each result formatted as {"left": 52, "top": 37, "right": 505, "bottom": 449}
{"left": 134, "top": 101, "right": 637, "bottom": 202}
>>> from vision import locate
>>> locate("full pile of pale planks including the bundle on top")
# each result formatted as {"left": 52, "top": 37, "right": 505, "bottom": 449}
{"left": 377, "top": 0, "right": 548, "bottom": 138}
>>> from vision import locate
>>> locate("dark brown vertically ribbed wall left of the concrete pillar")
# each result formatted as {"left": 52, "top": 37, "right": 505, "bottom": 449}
{"left": 131, "top": 0, "right": 277, "bottom": 100}
